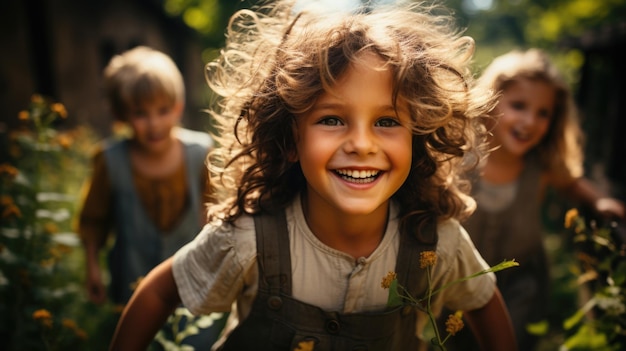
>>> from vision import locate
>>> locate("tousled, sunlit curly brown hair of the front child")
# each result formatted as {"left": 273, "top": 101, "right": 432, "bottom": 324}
{"left": 207, "top": 2, "right": 493, "bottom": 236}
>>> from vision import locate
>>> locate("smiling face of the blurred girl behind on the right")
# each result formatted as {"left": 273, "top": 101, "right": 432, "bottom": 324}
{"left": 493, "top": 79, "right": 555, "bottom": 157}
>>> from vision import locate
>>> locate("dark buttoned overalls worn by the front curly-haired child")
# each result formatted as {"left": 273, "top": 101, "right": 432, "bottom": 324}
{"left": 220, "top": 212, "right": 436, "bottom": 351}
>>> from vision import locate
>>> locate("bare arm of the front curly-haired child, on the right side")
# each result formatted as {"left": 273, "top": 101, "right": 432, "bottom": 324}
{"left": 465, "top": 288, "right": 517, "bottom": 351}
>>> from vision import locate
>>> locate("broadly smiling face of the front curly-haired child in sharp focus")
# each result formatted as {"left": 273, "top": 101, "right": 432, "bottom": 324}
{"left": 296, "top": 54, "right": 412, "bottom": 215}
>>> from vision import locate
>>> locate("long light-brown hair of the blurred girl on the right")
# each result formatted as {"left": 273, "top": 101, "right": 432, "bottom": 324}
{"left": 478, "top": 49, "right": 583, "bottom": 177}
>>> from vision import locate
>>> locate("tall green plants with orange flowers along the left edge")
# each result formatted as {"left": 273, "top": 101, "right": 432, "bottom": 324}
{"left": 0, "top": 95, "right": 95, "bottom": 350}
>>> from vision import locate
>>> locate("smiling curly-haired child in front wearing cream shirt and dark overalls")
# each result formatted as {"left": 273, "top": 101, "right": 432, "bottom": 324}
{"left": 111, "top": 1, "right": 515, "bottom": 351}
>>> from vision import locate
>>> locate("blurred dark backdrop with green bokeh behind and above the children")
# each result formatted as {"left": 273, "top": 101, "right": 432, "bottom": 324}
{"left": 0, "top": 0, "right": 626, "bottom": 197}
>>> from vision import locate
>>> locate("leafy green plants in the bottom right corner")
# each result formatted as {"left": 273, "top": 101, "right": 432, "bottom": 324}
{"left": 562, "top": 209, "right": 626, "bottom": 351}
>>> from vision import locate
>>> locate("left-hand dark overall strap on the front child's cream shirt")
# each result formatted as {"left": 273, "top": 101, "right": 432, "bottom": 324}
{"left": 254, "top": 210, "right": 291, "bottom": 295}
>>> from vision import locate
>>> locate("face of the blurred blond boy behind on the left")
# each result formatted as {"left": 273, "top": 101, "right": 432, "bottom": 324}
{"left": 126, "top": 99, "right": 183, "bottom": 154}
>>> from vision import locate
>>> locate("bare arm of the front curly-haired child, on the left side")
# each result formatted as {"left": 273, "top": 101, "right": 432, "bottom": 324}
{"left": 109, "top": 258, "right": 181, "bottom": 351}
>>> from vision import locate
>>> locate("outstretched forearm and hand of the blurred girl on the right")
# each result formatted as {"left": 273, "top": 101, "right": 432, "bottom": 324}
{"left": 564, "top": 177, "right": 626, "bottom": 219}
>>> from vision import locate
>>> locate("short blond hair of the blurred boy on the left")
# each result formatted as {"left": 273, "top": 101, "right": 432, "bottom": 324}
{"left": 104, "top": 46, "right": 185, "bottom": 120}
